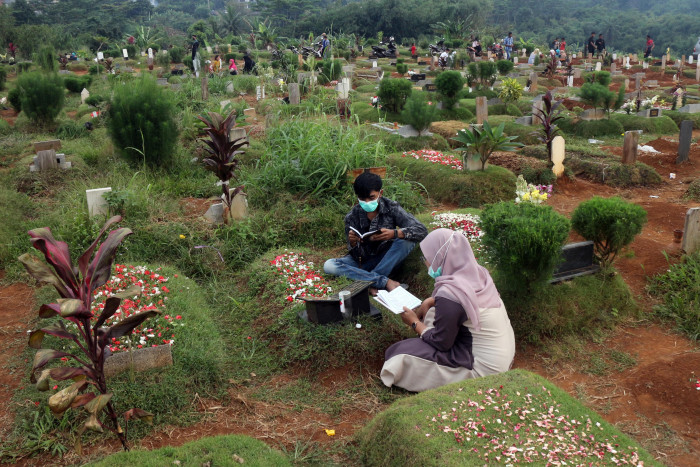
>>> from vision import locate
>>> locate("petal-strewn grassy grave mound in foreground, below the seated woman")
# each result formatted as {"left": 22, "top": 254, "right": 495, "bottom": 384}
{"left": 357, "top": 370, "right": 660, "bottom": 466}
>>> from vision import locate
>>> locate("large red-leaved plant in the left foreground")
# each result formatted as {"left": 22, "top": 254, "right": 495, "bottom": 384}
{"left": 19, "top": 216, "right": 158, "bottom": 453}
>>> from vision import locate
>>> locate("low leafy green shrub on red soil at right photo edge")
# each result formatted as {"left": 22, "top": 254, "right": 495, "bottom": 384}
{"left": 649, "top": 252, "right": 700, "bottom": 341}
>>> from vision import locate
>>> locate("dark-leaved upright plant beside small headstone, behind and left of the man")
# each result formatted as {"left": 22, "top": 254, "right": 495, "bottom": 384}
{"left": 197, "top": 110, "right": 247, "bottom": 221}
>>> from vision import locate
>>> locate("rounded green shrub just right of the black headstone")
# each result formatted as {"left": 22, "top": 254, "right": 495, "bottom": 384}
{"left": 571, "top": 196, "right": 647, "bottom": 265}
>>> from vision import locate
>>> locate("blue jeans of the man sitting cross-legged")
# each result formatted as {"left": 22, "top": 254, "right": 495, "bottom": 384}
{"left": 323, "top": 239, "right": 416, "bottom": 289}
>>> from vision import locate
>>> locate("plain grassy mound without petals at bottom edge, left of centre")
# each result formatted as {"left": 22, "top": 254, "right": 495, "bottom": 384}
{"left": 88, "top": 435, "right": 292, "bottom": 467}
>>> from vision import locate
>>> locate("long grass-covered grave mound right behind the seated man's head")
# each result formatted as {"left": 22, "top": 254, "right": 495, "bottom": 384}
{"left": 389, "top": 155, "right": 515, "bottom": 207}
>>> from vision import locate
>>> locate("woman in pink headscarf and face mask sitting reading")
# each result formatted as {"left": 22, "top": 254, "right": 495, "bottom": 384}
{"left": 381, "top": 229, "right": 515, "bottom": 391}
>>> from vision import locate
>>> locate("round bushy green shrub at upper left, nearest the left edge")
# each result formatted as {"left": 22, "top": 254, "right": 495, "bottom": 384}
{"left": 17, "top": 72, "right": 65, "bottom": 123}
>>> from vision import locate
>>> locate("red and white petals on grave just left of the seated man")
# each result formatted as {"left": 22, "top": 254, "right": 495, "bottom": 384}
{"left": 270, "top": 250, "right": 333, "bottom": 302}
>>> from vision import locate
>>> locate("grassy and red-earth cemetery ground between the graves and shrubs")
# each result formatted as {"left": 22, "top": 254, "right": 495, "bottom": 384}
{"left": 0, "top": 48, "right": 700, "bottom": 466}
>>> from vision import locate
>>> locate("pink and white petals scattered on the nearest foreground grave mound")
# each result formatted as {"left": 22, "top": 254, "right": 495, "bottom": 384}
{"left": 425, "top": 386, "right": 642, "bottom": 465}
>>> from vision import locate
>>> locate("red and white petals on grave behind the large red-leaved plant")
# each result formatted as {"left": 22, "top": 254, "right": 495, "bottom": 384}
{"left": 92, "top": 264, "right": 184, "bottom": 353}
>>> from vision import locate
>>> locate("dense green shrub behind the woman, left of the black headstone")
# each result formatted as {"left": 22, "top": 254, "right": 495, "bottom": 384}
{"left": 481, "top": 201, "right": 570, "bottom": 298}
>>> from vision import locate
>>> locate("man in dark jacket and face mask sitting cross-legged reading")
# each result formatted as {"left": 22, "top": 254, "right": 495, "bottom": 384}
{"left": 323, "top": 172, "right": 428, "bottom": 295}
